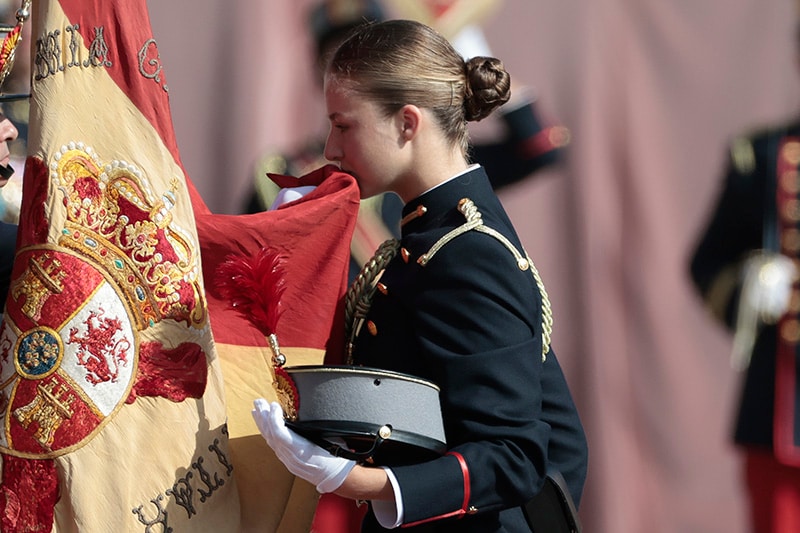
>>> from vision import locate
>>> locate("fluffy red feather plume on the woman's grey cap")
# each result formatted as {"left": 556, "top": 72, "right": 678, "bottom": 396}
{"left": 215, "top": 247, "right": 286, "bottom": 336}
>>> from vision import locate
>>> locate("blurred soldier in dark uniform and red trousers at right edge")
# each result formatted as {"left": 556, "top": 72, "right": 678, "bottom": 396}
{"left": 690, "top": 57, "right": 800, "bottom": 533}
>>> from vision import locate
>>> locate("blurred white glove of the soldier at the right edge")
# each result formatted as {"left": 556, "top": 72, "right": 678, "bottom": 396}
{"left": 739, "top": 254, "right": 797, "bottom": 324}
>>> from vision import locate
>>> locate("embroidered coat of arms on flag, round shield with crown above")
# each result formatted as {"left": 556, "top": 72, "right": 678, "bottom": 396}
{"left": 0, "top": 143, "right": 205, "bottom": 458}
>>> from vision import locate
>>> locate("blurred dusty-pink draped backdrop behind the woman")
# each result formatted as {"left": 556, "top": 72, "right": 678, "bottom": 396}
{"left": 150, "top": 0, "right": 800, "bottom": 533}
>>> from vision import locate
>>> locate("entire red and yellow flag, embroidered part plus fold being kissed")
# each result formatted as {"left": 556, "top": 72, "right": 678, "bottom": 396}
{"left": 0, "top": 0, "right": 358, "bottom": 532}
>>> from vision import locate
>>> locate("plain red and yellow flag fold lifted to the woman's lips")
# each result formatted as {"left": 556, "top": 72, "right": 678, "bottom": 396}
{"left": 196, "top": 166, "right": 359, "bottom": 533}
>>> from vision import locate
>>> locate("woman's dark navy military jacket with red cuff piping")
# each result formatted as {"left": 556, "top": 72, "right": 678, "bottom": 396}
{"left": 354, "top": 167, "right": 587, "bottom": 533}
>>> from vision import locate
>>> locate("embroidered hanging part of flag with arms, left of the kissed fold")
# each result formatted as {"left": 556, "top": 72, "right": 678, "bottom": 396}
{"left": 0, "top": 0, "right": 240, "bottom": 532}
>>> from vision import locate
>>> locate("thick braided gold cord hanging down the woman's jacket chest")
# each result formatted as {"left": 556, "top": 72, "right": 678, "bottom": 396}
{"left": 344, "top": 239, "right": 400, "bottom": 365}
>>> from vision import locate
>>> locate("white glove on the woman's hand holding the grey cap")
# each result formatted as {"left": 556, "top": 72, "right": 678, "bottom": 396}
{"left": 248, "top": 398, "right": 356, "bottom": 493}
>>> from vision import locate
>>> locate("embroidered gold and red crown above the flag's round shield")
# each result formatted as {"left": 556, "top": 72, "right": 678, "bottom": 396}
{"left": 50, "top": 142, "right": 207, "bottom": 329}
